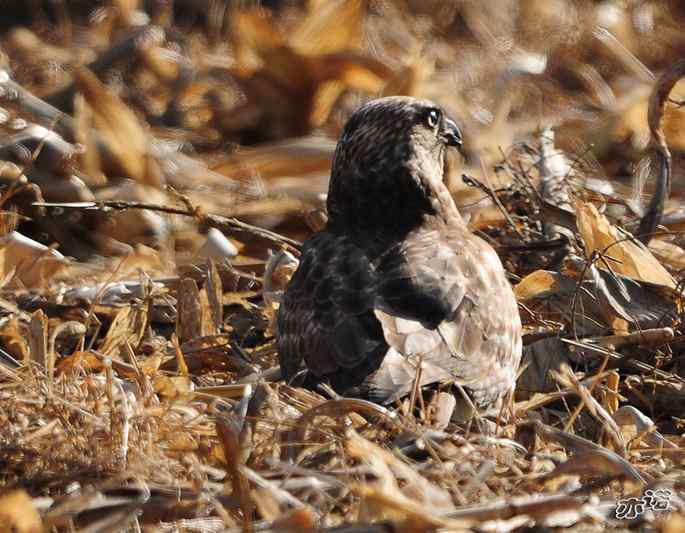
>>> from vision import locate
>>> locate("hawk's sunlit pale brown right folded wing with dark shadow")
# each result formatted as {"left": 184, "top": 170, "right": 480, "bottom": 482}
{"left": 369, "top": 224, "right": 521, "bottom": 405}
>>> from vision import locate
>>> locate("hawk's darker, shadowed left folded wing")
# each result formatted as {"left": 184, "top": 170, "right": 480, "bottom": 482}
{"left": 278, "top": 232, "right": 388, "bottom": 393}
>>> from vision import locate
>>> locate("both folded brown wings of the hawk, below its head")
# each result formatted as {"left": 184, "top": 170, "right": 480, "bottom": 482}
{"left": 278, "top": 228, "right": 521, "bottom": 405}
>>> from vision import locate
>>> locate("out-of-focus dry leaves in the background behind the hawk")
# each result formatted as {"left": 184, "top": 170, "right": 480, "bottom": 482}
{"left": 0, "top": 0, "right": 685, "bottom": 270}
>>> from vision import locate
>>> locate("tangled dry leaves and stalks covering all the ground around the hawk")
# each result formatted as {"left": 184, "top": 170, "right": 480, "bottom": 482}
{"left": 5, "top": 0, "right": 685, "bottom": 533}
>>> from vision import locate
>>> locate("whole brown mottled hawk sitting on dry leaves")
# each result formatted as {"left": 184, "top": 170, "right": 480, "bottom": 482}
{"left": 277, "top": 97, "right": 521, "bottom": 408}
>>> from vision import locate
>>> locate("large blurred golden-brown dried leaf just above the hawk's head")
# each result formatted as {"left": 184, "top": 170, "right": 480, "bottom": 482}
{"left": 226, "top": 5, "right": 392, "bottom": 139}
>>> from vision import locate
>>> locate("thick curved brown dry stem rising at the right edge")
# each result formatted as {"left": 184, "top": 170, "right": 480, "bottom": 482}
{"left": 637, "top": 59, "right": 685, "bottom": 244}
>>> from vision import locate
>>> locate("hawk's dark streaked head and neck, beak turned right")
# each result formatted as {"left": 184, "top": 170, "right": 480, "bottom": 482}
{"left": 328, "top": 97, "right": 462, "bottom": 237}
